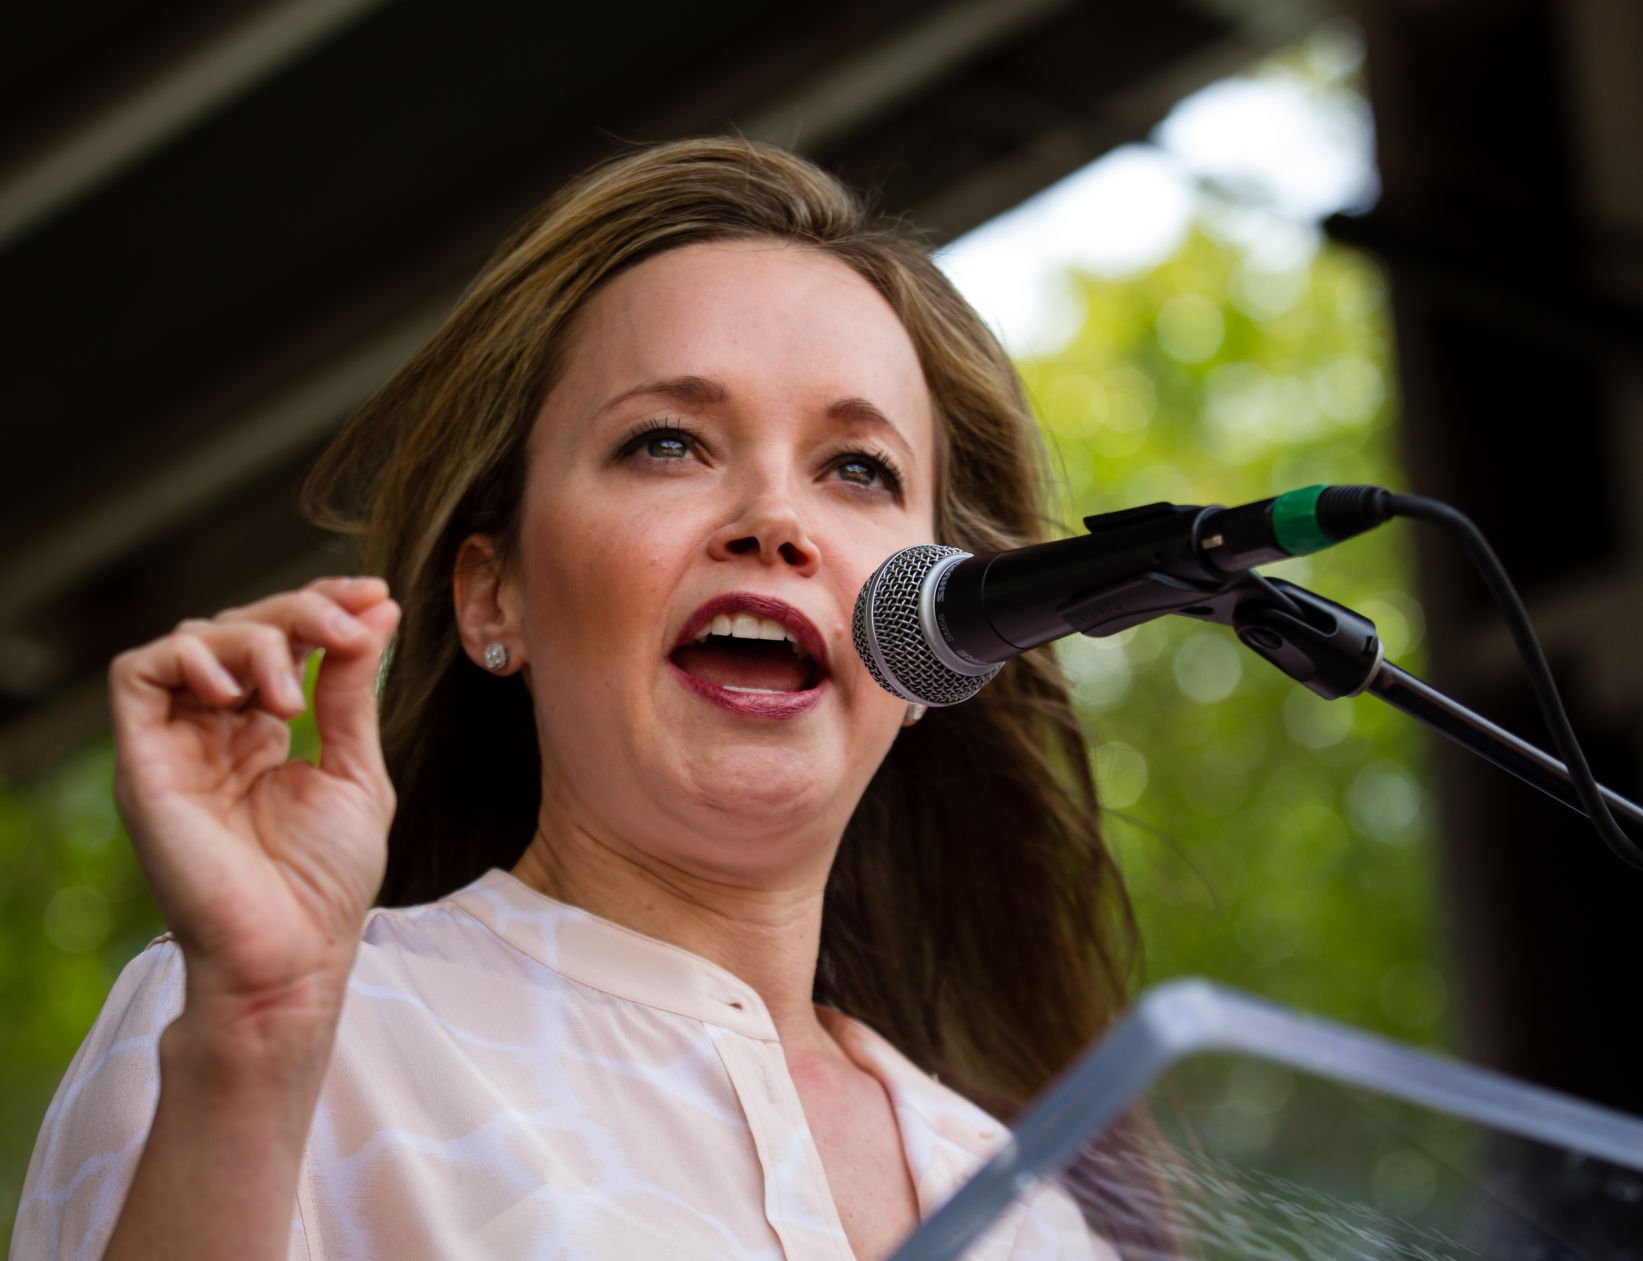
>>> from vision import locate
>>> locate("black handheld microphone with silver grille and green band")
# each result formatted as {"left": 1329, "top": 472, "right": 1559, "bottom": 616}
{"left": 851, "top": 485, "right": 1392, "bottom": 705}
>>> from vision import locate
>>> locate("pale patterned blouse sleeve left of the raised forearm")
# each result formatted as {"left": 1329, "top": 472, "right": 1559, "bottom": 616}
{"left": 12, "top": 937, "right": 184, "bottom": 1261}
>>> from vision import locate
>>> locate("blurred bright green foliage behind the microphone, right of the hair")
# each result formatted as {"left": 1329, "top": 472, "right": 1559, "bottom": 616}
{"left": 1022, "top": 223, "right": 1447, "bottom": 1044}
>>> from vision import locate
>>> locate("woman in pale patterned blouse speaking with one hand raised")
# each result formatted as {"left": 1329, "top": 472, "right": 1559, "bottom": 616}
{"left": 13, "top": 140, "right": 1132, "bottom": 1261}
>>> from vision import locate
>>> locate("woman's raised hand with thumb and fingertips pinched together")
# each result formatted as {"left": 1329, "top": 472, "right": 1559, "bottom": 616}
{"left": 108, "top": 579, "right": 399, "bottom": 1013}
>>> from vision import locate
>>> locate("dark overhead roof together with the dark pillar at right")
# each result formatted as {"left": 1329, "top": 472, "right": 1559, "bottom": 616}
{"left": 0, "top": 0, "right": 1643, "bottom": 1113}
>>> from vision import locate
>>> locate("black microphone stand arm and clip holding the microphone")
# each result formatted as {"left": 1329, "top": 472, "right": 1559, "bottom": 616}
{"left": 1169, "top": 570, "right": 1643, "bottom": 840}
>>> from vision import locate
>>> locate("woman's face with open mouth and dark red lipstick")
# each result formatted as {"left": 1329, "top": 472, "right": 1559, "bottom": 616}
{"left": 486, "top": 242, "right": 935, "bottom": 875}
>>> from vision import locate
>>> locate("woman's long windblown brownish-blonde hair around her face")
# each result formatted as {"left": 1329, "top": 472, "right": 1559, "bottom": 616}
{"left": 306, "top": 138, "right": 1134, "bottom": 1115}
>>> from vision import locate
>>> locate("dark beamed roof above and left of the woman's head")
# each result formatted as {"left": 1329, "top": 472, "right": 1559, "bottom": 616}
{"left": 0, "top": 0, "right": 1324, "bottom": 774}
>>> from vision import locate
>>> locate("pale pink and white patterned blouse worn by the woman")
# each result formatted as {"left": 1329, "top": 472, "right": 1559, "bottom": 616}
{"left": 12, "top": 870, "right": 1114, "bottom": 1261}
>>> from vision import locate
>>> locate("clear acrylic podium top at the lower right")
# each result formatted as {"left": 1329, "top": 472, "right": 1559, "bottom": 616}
{"left": 892, "top": 982, "right": 1643, "bottom": 1261}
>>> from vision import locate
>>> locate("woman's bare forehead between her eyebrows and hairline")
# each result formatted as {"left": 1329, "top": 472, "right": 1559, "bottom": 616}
{"left": 544, "top": 242, "right": 933, "bottom": 454}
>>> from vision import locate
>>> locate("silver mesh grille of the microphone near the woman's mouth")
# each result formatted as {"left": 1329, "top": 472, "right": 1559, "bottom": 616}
{"left": 851, "top": 543, "right": 1004, "bottom": 705}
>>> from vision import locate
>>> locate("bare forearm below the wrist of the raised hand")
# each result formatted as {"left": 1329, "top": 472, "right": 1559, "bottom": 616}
{"left": 104, "top": 996, "right": 342, "bottom": 1261}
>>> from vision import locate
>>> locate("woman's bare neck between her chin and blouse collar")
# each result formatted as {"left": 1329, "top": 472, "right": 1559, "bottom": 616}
{"left": 513, "top": 824, "right": 833, "bottom": 1055}
